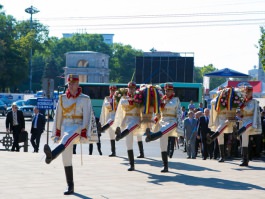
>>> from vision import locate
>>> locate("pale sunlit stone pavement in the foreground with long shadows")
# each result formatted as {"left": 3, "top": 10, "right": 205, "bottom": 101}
{"left": 0, "top": 152, "right": 265, "bottom": 199}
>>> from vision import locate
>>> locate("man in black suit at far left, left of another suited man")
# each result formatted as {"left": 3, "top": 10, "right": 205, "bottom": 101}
{"left": 6, "top": 104, "right": 25, "bottom": 152}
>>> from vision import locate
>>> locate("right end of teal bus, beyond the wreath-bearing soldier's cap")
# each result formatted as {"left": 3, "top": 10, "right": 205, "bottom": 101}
{"left": 159, "top": 82, "right": 204, "bottom": 109}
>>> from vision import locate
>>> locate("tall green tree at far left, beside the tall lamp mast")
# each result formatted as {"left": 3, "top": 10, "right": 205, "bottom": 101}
{"left": 0, "top": 5, "right": 48, "bottom": 91}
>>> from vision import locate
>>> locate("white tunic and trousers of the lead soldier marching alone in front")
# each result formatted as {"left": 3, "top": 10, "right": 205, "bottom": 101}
{"left": 53, "top": 93, "right": 92, "bottom": 166}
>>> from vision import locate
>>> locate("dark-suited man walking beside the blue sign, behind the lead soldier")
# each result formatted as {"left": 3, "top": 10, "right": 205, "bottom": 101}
{"left": 30, "top": 107, "right": 46, "bottom": 153}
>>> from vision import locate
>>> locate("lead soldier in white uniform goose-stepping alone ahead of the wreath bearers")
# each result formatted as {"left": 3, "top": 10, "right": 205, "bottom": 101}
{"left": 44, "top": 74, "right": 92, "bottom": 195}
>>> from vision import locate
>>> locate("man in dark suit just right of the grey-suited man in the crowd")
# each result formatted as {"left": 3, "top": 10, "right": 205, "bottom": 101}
{"left": 198, "top": 108, "right": 212, "bottom": 160}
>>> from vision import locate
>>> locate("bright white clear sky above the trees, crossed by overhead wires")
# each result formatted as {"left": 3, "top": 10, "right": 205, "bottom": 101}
{"left": 0, "top": 0, "right": 265, "bottom": 74}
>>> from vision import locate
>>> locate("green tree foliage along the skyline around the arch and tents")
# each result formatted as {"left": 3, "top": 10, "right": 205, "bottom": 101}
{"left": 0, "top": 5, "right": 265, "bottom": 94}
